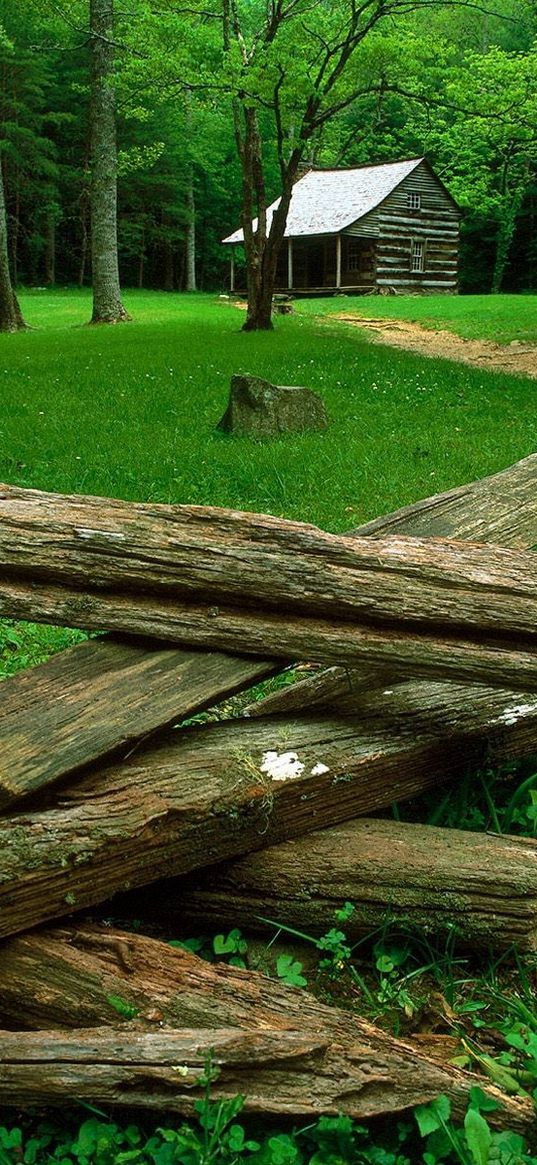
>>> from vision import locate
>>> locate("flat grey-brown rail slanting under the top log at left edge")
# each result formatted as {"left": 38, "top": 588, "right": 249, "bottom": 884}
{"left": 0, "top": 636, "right": 276, "bottom": 809}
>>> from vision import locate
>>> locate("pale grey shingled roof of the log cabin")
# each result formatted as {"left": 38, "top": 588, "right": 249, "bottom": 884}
{"left": 222, "top": 157, "right": 424, "bottom": 243}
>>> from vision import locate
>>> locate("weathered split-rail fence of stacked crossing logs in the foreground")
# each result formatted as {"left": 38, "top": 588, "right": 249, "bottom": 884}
{"left": 0, "top": 456, "right": 537, "bottom": 1134}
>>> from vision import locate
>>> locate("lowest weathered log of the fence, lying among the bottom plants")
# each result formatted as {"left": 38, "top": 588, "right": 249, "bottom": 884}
{"left": 0, "top": 1025, "right": 528, "bottom": 1132}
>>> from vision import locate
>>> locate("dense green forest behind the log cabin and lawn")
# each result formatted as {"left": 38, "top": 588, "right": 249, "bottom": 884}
{"left": 0, "top": 0, "right": 537, "bottom": 305}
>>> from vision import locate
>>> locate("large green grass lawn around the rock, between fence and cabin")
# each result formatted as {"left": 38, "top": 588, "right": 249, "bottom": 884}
{"left": 0, "top": 291, "right": 537, "bottom": 531}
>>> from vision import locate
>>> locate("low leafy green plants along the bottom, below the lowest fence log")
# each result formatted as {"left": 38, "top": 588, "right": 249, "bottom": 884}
{"left": 0, "top": 1090, "right": 537, "bottom": 1165}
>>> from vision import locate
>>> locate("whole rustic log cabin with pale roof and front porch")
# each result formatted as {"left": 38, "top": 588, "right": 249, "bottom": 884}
{"left": 222, "top": 157, "right": 460, "bottom": 295}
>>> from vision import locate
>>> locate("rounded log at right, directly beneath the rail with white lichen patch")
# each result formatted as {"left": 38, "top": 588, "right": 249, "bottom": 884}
{"left": 160, "top": 819, "right": 537, "bottom": 952}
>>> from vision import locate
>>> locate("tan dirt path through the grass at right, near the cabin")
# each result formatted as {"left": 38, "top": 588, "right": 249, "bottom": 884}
{"left": 331, "top": 312, "right": 537, "bottom": 379}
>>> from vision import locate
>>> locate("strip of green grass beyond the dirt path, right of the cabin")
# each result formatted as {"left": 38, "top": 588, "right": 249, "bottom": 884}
{"left": 297, "top": 295, "right": 537, "bottom": 344}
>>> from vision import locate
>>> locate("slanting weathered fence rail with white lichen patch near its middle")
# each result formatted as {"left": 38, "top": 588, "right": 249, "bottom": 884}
{"left": 0, "top": 684, "right": 537, "bottom": 935}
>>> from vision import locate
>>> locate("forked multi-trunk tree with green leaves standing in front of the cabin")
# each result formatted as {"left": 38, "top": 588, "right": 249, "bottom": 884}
{"left": 215, "top": 0, "right": 464, "bottom": 331}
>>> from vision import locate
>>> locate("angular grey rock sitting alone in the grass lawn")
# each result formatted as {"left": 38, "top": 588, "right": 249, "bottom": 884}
{"left": 217, "top": 375, "right": 328, "bottom": 437}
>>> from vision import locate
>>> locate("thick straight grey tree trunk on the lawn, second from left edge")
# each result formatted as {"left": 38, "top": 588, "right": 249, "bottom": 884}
{"left": 90, "top": 0, "right": 130, "bottom": 324}
